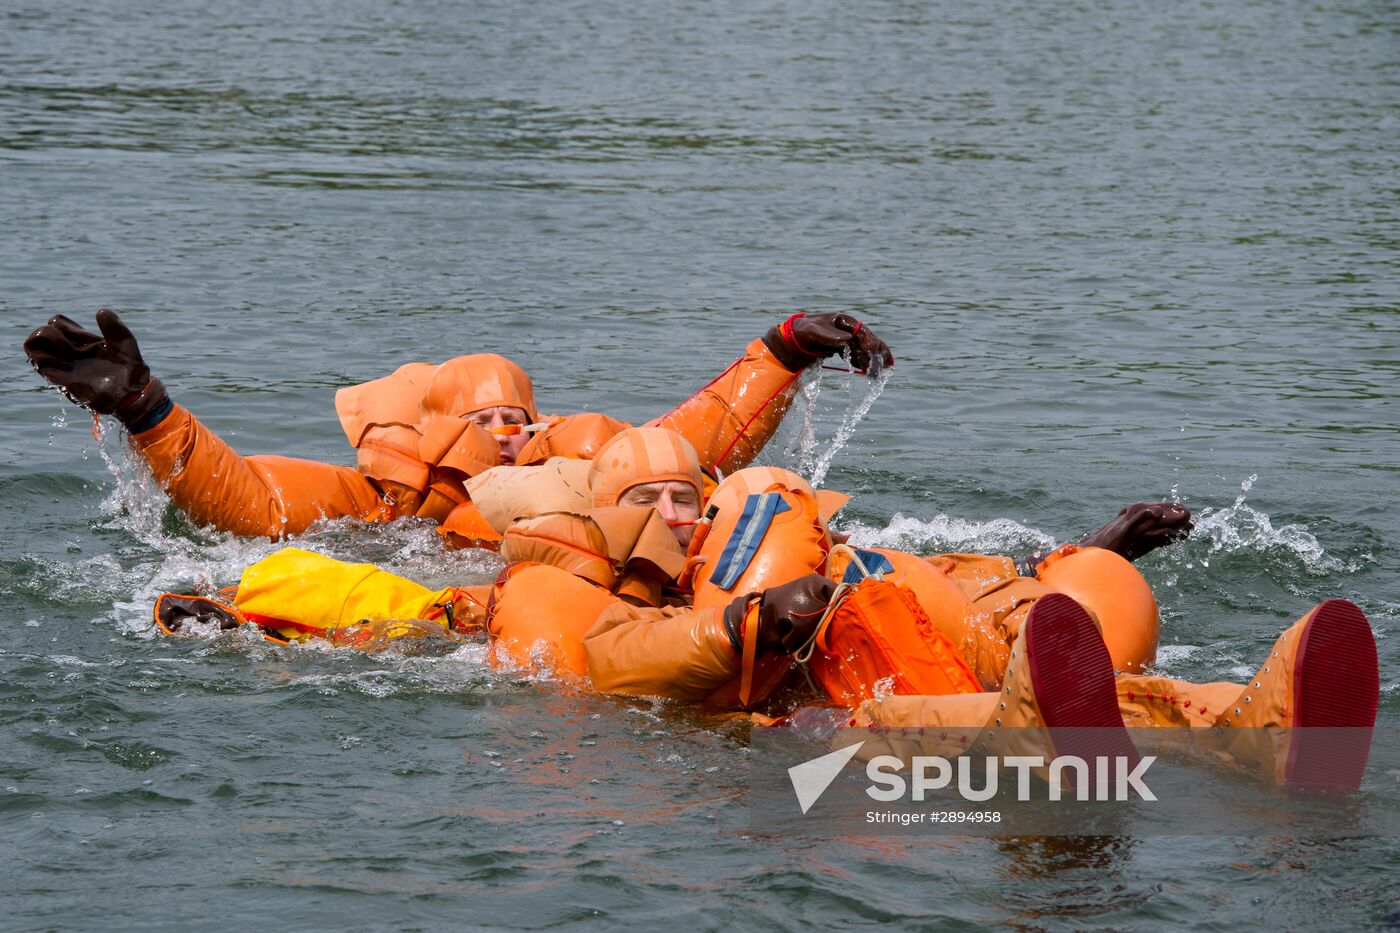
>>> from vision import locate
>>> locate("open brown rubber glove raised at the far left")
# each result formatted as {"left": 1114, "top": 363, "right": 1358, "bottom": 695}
{"left": 24, "top": 308, "right": 171, "bottom": 433}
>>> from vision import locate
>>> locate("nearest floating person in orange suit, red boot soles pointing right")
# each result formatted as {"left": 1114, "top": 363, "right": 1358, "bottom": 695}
{"left": 584, "top": 468, "right": 1379, "bottom": 792}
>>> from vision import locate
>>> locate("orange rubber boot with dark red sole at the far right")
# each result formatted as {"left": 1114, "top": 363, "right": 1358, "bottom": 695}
{"left": 1215, "top": 600, "right": 1380, "bottom": 793}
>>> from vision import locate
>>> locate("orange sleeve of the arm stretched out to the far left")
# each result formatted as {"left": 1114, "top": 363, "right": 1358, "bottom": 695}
{"left": 132, "top": 405, "right": 393, "bottom": 539}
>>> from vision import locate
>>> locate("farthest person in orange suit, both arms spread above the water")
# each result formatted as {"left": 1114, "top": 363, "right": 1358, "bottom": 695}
{"left": 24, "top": 308, "right": 893, "bottom": 544}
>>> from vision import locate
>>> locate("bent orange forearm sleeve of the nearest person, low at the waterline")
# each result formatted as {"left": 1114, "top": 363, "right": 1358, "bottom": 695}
{"left": 584, "top": 602, "right": 739, "bottom": 700}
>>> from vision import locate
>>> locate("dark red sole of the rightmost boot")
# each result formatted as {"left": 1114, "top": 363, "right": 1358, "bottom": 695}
{"left": 1285, "top": 600, "right": 1380, "bottom": 793}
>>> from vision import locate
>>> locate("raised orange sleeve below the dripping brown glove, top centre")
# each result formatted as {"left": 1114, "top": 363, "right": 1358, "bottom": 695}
{"left": 647, "top": 339, "right": 802, "bottom": 474}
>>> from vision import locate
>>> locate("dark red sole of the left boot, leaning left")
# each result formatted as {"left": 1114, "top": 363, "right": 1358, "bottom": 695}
{"left": 1021, "top": 593, "right": 1138, "bottom": 765}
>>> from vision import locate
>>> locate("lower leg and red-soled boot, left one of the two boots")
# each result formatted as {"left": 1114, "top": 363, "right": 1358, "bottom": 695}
{"left": 851, "top": 594, "right": 1138, "bottom": 776}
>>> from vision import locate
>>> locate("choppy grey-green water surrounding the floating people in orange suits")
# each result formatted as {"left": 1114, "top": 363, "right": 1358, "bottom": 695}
{"left": 0, "top": 0, "right": 1400, "bottom": 929}
